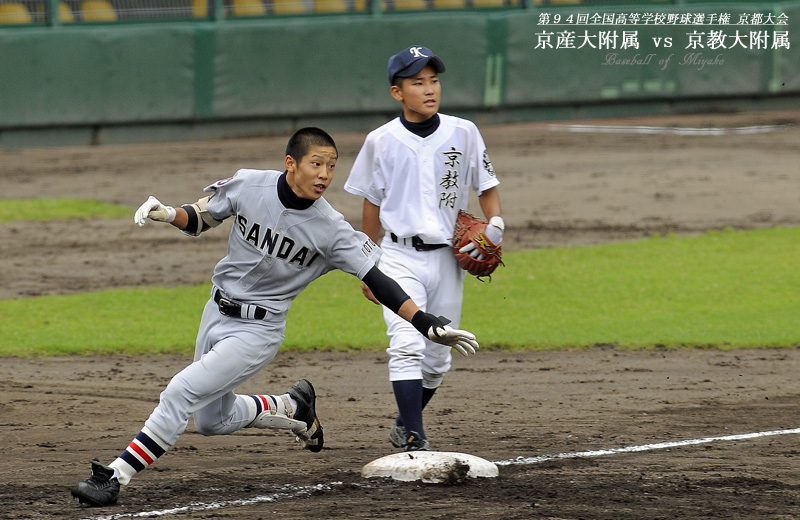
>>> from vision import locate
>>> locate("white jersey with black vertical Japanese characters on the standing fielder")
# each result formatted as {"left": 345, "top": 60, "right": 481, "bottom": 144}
{"left": 344, "top": 114, "right": 499, "bottom": 244}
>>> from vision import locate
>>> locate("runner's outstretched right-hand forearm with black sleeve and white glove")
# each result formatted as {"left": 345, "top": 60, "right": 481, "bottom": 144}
{"left": 363, "top": 266, "right": 479, "bottom": 356}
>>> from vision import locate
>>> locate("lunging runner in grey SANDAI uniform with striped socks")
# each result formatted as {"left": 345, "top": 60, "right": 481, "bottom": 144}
{"left": 72, "top": 128, "right": 478, "bottom": 506}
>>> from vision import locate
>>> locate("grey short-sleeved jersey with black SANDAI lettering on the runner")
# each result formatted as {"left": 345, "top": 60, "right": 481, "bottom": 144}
{"left": 205, "top": 169, "right": 380, "bottom": 314}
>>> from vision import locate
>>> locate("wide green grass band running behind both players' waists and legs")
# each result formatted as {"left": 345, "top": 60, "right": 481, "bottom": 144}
{"left": 0, "top": 227, "right": 800, "bottom": 356}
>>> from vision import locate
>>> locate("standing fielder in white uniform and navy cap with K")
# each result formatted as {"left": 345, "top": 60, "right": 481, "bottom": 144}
{"left": 345, "top": 46, "right": 505, "bottom": 449}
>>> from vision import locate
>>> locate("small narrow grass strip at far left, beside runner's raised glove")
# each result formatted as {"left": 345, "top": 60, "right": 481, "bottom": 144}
{"left": 0, "top": 198, "right": 133, "bottom": 223}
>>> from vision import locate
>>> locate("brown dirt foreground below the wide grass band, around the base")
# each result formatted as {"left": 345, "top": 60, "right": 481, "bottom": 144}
{"left": 0, "top": 349, "right": 800, "bottom": 520}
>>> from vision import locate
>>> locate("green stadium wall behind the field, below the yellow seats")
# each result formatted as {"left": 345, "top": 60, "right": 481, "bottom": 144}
{"left": 0, "top": 2, "right": 800, "bottom": 148}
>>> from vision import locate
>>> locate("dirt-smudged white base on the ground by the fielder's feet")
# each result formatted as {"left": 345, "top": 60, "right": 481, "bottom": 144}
{"left": 361, "top": 451, "right": 499, "bottom": 484}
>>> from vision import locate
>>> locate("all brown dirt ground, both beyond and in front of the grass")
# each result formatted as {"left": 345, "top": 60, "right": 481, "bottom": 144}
{"left": 0, "top": 113, "right": 800, "bottom": 520}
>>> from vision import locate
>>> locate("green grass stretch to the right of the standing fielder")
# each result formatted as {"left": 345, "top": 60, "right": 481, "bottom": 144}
{"left": 463, "top": 228, "right": 800, "bottom": 348}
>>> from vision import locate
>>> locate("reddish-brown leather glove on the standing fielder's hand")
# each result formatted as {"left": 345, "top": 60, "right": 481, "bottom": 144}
{"left": 453, "top": 210, "right": 503, "bottom": 280}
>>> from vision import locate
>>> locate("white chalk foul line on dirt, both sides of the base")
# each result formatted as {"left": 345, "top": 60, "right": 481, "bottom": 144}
{"left": 82, "top": 428, "right": 800, "bottom": 520}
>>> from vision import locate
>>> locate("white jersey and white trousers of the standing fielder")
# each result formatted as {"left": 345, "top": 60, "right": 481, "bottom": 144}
{"left": 345, "top": 114, "right": 499, "bottom": 382}
